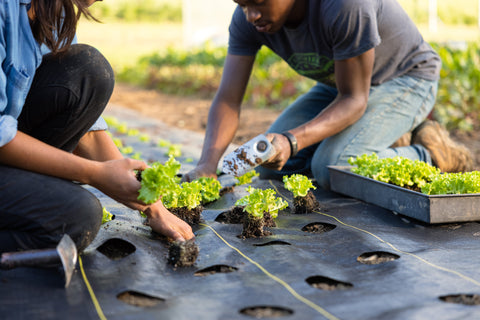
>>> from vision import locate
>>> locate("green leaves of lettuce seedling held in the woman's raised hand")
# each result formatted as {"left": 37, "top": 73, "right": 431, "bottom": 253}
{"left": 138, "top": 157, "right": 181, "bottom": 204}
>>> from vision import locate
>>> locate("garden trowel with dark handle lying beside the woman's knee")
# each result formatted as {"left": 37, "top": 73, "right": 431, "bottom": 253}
{"left": 0, "top": 234, "right": 77, "bottom": 288}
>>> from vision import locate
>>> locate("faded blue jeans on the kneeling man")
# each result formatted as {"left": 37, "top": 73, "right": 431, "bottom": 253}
{"left": 258, "top": 75, "right": 438, "bottom": 189}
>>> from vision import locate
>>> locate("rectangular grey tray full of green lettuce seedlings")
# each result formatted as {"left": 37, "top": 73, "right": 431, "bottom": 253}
{"left": 328, "top": 154, "right": 480, "bottom": 224}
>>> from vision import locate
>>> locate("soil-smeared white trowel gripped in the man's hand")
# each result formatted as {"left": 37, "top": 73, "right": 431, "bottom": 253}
{"left": 222, "top": 134, "right": 275, "bottom": 177}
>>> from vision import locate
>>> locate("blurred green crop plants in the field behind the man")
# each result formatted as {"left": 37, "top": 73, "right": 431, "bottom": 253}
{"left": 117, "top": 42, "right": 480, "bottom": 131}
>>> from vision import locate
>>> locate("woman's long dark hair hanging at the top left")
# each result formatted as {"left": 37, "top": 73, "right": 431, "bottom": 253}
{"left": 31, "top": 0, "right": 96, "bottom": 53}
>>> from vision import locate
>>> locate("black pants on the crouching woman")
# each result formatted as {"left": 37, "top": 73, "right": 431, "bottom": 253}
{"left": 0, "top": 44, "right": 114, "bottom": 253}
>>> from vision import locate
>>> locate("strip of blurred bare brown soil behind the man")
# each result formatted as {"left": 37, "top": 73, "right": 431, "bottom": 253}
{"left": 111, "top": 83, "right": 480, "bottom": 170}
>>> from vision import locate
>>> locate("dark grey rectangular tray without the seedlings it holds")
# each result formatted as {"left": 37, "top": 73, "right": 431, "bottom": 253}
{"left": 328, "top": 166, "right": 480, "bottom": 224}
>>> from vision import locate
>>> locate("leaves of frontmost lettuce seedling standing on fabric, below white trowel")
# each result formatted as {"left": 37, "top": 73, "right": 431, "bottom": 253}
{"left": 235, "top": 186, "right": 288, "bottom": 219}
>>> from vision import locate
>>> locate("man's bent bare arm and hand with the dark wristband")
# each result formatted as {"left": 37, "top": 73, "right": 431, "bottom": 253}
{"left": 264, "top": 49, "right": 375, "bottom": 170}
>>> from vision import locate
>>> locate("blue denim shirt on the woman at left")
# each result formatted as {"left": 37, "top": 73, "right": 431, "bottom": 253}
{"left": 0, "top": 0, "right": 107, "bottom": 147}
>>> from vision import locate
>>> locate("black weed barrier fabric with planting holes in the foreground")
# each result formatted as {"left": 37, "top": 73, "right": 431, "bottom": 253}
{"left": 0, "top": 109, "right": 480, "bottom": 320}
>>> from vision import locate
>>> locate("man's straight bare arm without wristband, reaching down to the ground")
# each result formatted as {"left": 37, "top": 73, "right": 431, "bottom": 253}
{"left": 184, "top": 54, "right": 255, "bottom": 181}
